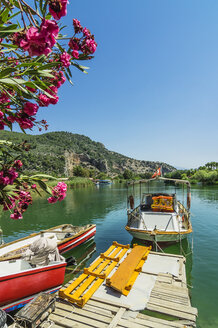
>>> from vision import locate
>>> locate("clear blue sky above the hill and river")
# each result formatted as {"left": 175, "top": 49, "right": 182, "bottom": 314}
{"left": 31, "top": 0, "right": 218, "bottom": 168}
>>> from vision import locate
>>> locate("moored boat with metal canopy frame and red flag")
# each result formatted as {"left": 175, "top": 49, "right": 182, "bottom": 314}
{"left": 125, "top": 177, "right": 192, "bottom": 242}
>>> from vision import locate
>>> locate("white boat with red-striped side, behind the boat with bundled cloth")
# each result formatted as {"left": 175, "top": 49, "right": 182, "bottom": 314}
{"left": 0, "top": 224, "right": 96, "bottom": 261}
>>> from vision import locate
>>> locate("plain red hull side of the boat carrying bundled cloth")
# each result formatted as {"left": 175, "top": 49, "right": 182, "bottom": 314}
{"left": 0, "top": 262, "right": 66, "bottom": 306}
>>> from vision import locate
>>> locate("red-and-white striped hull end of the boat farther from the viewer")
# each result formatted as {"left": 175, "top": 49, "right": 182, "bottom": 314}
{"left": 58, "top": 226, "right": 96, "bottom": 254}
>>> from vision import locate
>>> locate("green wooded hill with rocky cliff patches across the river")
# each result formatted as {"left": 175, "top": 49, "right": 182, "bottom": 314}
{"left": 0, "top": 131, "right": 175, "bottom": 176}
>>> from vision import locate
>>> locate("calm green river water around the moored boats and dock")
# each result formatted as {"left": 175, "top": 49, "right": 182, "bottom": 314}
{"left": 0, "top": 184, "right": 218, "bottom": 328}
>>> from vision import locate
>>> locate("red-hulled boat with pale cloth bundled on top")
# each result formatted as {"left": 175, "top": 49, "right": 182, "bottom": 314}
{"left": 0, "top": 236, "right": 67, "bottom": 310}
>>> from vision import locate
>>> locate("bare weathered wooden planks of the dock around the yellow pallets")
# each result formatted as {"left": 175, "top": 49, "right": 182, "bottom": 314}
{"left": 40, "top": 252, "right": 197, "bottom": 328}
